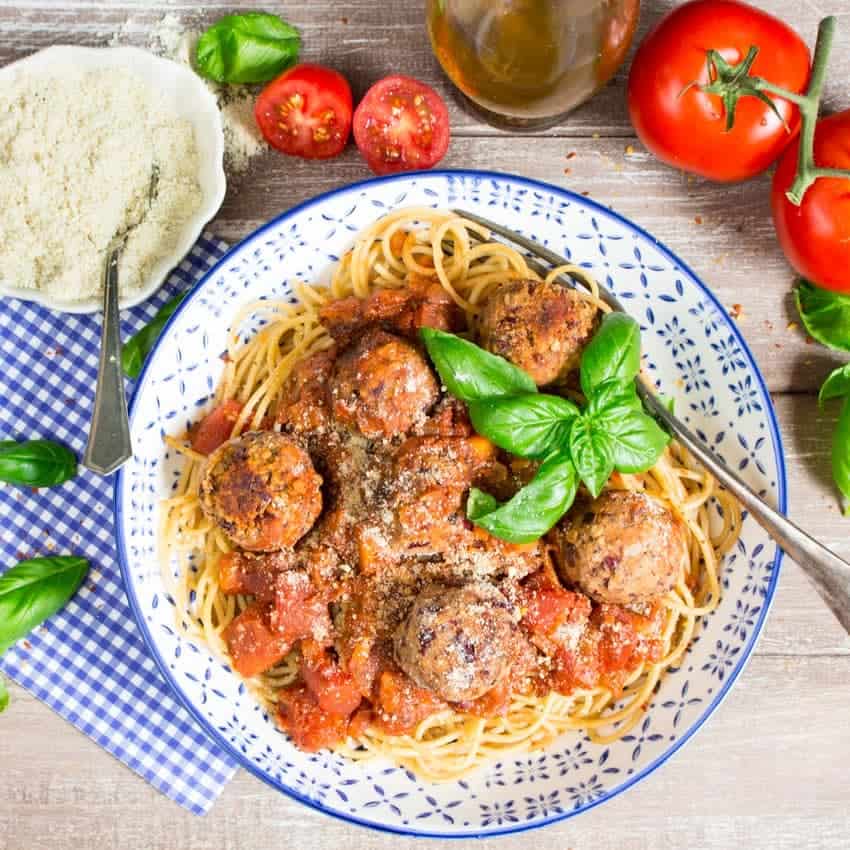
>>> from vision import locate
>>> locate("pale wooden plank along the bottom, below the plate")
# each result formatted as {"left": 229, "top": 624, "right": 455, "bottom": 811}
{"left": 0, "top": 657, "right": 850, "bottom": 850}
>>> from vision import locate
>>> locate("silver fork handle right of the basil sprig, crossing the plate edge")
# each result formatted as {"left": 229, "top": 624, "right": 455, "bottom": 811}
{"left": 637, "top": 381, "right": 850, "bottom": 633}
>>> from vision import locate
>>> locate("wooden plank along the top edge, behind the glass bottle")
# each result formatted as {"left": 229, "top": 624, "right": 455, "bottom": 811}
{"left": 0, "top": 0, "right": 850, "bottom": 136}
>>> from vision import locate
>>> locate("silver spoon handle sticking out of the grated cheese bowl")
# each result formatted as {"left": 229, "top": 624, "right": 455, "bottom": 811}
{"left": 83, "top": 240, "right": 133, "bottom": 475}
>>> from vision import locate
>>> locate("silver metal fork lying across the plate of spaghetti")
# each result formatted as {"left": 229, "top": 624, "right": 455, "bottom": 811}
{"left": 452, "top": 204, "right": 850, "bottom": 633}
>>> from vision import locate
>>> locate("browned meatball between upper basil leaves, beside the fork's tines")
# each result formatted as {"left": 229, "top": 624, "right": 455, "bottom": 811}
{"left": 480, "top": 280, "right": 598, "bottom": 386}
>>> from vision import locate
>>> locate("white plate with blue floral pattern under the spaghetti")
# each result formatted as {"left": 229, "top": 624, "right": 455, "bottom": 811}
{"left": 115, "top": 171, "right": 786, "bottom": 837}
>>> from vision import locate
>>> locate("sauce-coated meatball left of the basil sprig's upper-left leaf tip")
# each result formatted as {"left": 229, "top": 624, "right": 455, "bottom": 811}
{"left": 331, "top": 330, "right": 439, "bottom": 439}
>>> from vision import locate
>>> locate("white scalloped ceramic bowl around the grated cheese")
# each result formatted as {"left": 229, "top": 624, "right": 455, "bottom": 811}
{"left": 0, "top": 45, "right": 227, "bottom": 313}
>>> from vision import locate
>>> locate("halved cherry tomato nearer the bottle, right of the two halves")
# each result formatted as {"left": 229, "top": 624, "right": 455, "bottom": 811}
{"left": 354, "top": 76, "right": 449, "bottom": 174}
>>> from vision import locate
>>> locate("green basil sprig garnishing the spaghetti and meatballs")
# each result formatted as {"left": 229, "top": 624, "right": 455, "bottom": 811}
{"left": 422, "top": 313, "right": 669, "bottom": 543}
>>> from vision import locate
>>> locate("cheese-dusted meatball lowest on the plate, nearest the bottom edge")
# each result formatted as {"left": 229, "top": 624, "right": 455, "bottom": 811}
{"left": 394, "top": 582, "right": 514, "bottom": 702}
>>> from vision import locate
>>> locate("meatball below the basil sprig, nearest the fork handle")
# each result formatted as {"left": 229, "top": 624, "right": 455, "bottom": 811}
{"left": 554, "top": 490, "right": 688, "bottom": 605}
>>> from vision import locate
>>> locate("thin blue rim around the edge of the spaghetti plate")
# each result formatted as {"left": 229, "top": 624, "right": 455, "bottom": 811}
{"left": 113, "top": 169, "right": 787, "bottom": 839}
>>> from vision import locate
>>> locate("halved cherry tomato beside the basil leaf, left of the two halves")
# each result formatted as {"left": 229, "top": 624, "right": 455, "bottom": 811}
{"left": 254, "top": 64, "right": 351, "bottom": 159}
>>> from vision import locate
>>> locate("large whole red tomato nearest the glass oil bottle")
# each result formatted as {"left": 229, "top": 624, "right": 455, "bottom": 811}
{"left": 628, "top": 0, "right": 809, "bottom": 182}
